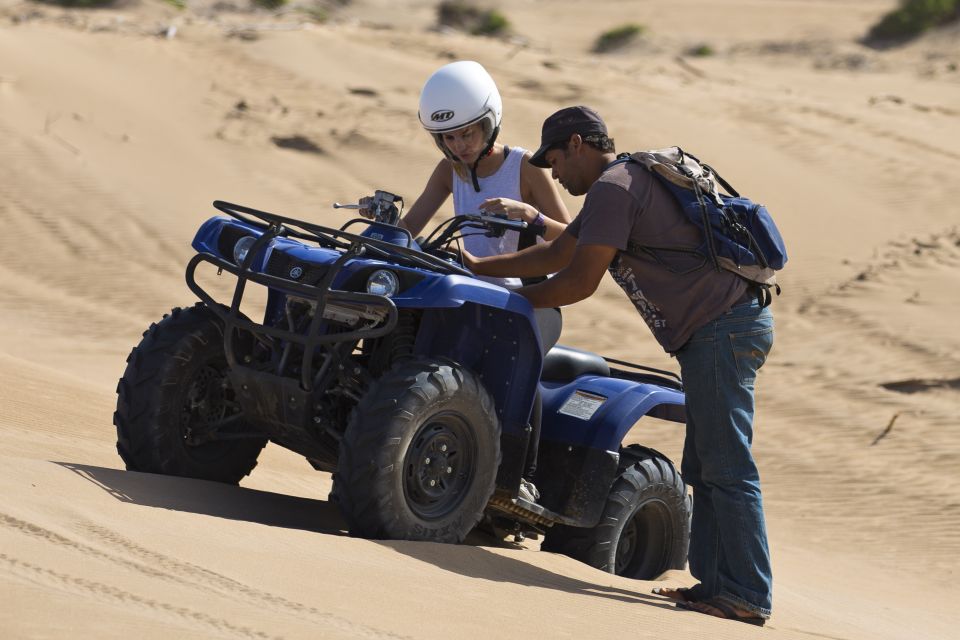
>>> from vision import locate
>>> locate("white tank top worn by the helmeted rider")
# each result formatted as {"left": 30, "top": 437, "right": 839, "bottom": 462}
{"left": 453, "top": 147, "right": 526, "bottom": 289}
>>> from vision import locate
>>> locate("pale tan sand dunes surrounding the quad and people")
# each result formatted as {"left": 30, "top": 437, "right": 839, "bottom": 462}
{"left": 0, "top": 0, "right": 960, "bottom": 640}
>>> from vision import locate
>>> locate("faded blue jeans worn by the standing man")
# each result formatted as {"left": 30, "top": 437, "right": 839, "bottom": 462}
{"left": 676, "top": 302, "right": 773, "bottom": 617}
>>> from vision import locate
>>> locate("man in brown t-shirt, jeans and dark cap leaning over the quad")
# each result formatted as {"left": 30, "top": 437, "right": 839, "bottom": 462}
{"left": 464, "top": 106, "right": 773, "bottom": 625}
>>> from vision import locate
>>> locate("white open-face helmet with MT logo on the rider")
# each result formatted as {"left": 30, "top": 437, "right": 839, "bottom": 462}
{"left": 418, "top": 60, "right": 503, "bottom": 165}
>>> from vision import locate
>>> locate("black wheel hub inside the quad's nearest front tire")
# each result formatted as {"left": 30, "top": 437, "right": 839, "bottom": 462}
{"left": 404, "top": 413, "right": 477, "bottom": 520}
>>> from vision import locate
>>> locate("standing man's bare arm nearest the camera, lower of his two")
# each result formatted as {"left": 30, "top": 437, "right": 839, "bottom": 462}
{"left": 517, "top": 242, "right": 617, "bottom": 307}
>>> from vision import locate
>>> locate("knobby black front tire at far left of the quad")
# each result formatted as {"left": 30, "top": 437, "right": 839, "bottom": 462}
{"left": 113, "top": 304, "right": 267, "bottom": 484}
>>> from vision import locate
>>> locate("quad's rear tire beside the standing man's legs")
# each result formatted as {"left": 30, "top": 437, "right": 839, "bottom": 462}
{"left": 541, "top": 446, "right": 690, "bottom": 580}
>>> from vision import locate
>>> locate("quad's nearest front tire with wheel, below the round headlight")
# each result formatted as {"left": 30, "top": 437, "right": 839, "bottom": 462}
{"left": 336, "top": 358, "right": 500, "bottom": 543}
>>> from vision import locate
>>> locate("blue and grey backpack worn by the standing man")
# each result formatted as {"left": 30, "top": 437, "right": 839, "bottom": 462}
{"left": 620, "top": 147, "right": 787, "bottom": 306}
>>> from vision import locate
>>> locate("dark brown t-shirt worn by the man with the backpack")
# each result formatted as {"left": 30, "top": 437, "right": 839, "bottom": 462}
{"left": 567, "top": 162, "right": 747, "bottom": 353}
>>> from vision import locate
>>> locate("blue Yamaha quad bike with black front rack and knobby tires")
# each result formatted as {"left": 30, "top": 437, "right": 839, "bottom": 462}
{"left": 114, "top": 191, "right": 690, "bottom": 579}
